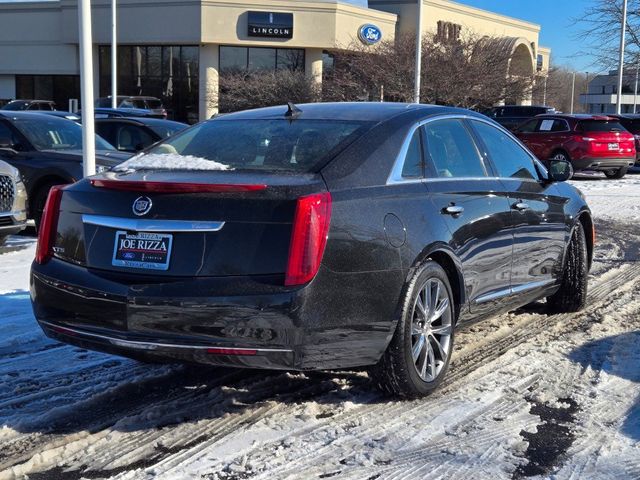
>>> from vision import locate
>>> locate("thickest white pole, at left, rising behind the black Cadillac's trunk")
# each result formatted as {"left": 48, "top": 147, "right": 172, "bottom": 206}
{"left": 78, "top": 0, "right": 96, "bottom": 177}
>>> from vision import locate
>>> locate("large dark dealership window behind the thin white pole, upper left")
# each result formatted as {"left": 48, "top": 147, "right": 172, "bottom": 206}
{"left": 99, "top": 45, "right": 199, "bottom": 123}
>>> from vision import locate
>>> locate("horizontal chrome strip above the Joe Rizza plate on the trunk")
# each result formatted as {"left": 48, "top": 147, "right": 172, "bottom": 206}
{"left": 82, "top": 214, "right": 224, "bottom": 233}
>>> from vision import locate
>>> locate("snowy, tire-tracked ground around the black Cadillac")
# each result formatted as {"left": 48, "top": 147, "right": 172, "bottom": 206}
{"left": 0, "top": 171, "right": 640, "bottom": 480}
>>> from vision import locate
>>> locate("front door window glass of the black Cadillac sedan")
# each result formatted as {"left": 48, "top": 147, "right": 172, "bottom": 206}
{"left": 472, "top": 121, "right": 539, "bottom": 180}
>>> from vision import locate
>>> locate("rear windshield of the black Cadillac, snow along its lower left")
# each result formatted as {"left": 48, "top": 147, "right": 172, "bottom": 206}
{"left": 137, "top": 118, "right": 370, "bottom": 172}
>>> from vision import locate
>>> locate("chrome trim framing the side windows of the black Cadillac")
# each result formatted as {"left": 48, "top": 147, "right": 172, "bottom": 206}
{"left": 386, "top": 113, "right": 547, "bottom": 185}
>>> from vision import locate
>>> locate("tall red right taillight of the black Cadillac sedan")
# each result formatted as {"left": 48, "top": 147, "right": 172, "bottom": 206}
{"left": 284, "top": 192, "right": 331, "bottom": 286}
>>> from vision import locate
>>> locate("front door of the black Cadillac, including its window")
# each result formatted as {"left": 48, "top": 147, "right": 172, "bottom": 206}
{"left": 470, "top": 120, "right": 566, "bottom": 293}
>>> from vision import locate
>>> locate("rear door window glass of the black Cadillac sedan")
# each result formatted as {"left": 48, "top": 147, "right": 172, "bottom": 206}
{"left": 424, "top": 119, "right": 487, "bottom": 178}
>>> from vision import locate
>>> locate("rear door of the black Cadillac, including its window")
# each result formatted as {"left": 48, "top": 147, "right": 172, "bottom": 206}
{"left": 422, "top": 118, "right": 513, "bottom": 313}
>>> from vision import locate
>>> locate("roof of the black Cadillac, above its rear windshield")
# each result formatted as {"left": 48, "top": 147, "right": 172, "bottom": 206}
{"left": 214, "top": 102, "right": 486, "bottom": 122}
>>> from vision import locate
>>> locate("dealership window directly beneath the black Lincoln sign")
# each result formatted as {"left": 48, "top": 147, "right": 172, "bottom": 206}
{"left": 220, "top": 47, "right": 304, "bottom": 73}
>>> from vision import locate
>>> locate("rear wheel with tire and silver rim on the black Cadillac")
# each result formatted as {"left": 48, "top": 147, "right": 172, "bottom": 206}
{"left": 370, "top": 260, "right": 456, "bottom": 398}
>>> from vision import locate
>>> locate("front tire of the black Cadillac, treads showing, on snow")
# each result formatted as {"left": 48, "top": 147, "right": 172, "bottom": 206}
{"left": 547, "top": 221, "right": 589, "bottom": 313}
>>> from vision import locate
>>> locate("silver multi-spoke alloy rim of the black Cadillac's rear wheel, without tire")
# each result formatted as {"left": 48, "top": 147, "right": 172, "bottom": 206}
{"left": 411, "top": 278, "right": 453, "bottom": 382}
